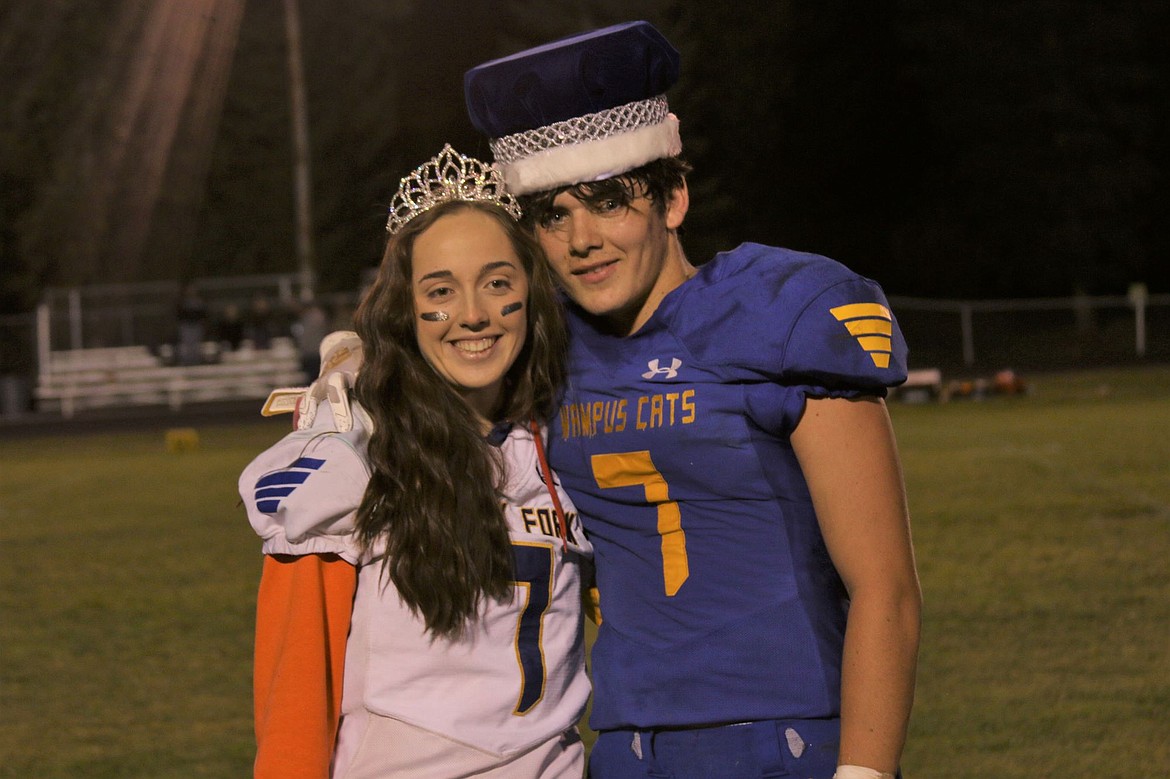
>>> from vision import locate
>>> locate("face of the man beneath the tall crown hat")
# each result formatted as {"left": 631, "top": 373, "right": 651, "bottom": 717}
{"left": 536, "top": 180, "right": 688, "bottom": 335}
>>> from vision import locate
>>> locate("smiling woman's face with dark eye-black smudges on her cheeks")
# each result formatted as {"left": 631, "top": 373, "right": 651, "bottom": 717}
{"left": 411, "top": 208, "right": 528, "bottom": 421}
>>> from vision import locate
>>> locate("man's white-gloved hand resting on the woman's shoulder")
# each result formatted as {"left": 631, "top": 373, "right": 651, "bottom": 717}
{"left": 260, "top": 330, "right": 362, "bottom": 433}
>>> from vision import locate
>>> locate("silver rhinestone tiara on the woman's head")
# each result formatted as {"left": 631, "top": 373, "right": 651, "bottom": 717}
{"left": 386, "top": 144, "right": 521, "bottom": 235}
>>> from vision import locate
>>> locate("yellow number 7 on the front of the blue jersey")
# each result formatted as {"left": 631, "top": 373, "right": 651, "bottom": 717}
{"left": 591, "top": 449, "right": 690, "bottom": 598}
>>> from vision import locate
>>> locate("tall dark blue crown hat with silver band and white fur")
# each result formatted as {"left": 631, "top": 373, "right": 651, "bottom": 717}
{"left": 463, "top": 21, "right": 682, "bottom": 194}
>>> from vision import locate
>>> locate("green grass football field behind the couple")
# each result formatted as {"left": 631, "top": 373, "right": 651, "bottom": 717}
{"left": 0, "top": 368, "right": 1170, "bottom": 779}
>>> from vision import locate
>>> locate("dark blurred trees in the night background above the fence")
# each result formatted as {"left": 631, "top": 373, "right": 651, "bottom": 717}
{"left": 0, "top": 0, "right": 1170, "bottom": 313}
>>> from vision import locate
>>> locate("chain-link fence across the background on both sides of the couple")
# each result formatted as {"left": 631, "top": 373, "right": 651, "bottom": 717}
{"left": 0, "top": 274, "right": 1170, "bottom": 414}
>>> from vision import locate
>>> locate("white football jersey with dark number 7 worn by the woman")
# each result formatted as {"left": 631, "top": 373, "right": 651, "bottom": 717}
{"left": 240, "top": 407, "right": 592, "bottom": 754}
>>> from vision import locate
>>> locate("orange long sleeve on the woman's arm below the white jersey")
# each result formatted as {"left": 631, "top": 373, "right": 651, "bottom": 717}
{"left": 253, "top": 554, "right": 357, "bottom": 779}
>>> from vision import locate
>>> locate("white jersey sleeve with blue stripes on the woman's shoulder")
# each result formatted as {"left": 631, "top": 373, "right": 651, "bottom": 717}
{"left": 239, "top": 402, "right": 370, "bottom": 564}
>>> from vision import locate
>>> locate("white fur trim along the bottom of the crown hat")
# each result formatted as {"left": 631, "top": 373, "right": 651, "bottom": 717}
{"left": 496, "top": 113, "right": 682, "bottom": 195}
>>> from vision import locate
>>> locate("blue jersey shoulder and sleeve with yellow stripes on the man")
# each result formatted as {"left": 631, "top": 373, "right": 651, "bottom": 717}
{"left": 680, "top": 243, "right": 907, "bottom": 434}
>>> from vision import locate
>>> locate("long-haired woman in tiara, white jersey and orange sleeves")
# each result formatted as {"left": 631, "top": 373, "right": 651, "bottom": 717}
{"left": 240, "top": 146, "right": 592, "bottom": 779}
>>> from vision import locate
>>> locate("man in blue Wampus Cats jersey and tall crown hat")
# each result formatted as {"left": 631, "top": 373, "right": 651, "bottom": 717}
{"left": 464, "top": 22, "right": 921, "bottom": 779}
